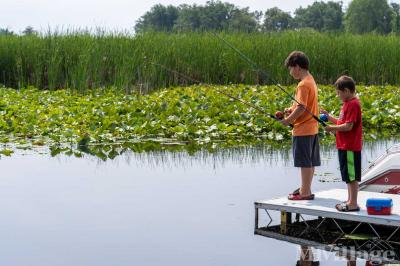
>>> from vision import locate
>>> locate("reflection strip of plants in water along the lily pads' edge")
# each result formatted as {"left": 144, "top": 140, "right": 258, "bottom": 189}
{"left": 2, "top": 136, "right": 396, "bottom": 168}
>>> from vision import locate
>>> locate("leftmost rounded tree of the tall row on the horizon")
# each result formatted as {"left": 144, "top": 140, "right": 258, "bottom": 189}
{"left": 135, "top": 4, "right": 179, "bottom": 32}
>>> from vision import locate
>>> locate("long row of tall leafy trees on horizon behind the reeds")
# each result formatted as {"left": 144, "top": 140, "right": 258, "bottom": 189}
{"left": 135, "top": 0, "right": 400, "bottom": 34}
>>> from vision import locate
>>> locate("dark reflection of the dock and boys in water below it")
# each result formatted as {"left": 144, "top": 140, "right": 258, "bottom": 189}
{"left": 255, "top": 219, "right": 400, "bottom": 265}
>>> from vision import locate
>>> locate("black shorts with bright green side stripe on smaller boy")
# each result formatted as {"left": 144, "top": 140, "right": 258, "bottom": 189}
{"left": 338, "top": 150, "right": 361, "bottom": 184}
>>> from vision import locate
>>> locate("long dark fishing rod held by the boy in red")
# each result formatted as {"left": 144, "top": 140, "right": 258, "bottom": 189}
{"left": 212, "top": 32, "right": 327, "bottom": 127}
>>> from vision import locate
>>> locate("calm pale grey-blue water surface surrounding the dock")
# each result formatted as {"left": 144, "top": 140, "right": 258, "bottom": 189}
{"left": 0, "top": 141, "right": 393, "bottom": 266}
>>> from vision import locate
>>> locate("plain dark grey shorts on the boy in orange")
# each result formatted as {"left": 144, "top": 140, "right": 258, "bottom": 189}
{"left": 292, "top": 135, "right": 321, "bottom": 167}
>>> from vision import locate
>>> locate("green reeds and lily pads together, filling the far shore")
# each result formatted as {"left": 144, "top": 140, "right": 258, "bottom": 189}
{"left": 0, "top": 32, "right": 400, "bottom": 159}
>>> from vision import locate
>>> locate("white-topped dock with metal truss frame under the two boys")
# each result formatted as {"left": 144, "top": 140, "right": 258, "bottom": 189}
{"left": 254, "top": 189, "right": 400, "bottom": 254}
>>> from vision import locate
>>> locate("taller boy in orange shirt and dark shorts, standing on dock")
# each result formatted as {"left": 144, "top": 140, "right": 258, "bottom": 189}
{"left": 281, "top": 51, "right": 321, "bottom": 200}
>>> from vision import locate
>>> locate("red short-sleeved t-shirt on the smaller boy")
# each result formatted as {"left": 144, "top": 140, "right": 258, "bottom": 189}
{"left": 336, "top": 97, "right": 362, "bottom": 151}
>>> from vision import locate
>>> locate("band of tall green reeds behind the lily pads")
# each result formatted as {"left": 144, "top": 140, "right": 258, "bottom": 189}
{"left": 0, "top": 31, "right": 400, "bottom": 91}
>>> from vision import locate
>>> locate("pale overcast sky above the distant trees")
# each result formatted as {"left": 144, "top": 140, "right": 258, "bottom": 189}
{"left": 0, "top": 0, "right": 356, "bottom": 32}
